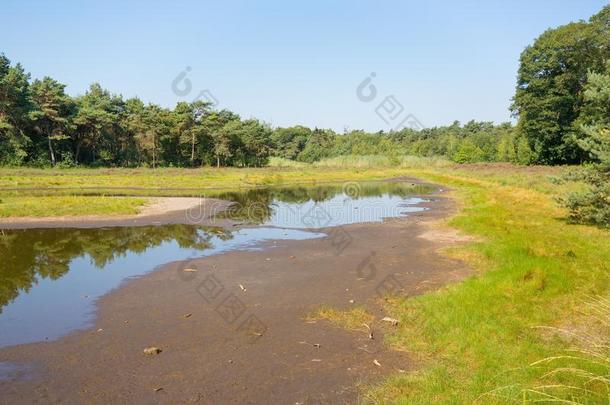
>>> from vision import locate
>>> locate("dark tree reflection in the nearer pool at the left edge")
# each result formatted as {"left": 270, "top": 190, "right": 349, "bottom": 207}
{"left": 0, "top": 225, "right": 223, "bottom": 313}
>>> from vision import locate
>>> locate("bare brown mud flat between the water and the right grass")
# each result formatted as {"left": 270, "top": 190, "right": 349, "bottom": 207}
{"left": 0, "top": 188, "right": 468, "bottom": 404}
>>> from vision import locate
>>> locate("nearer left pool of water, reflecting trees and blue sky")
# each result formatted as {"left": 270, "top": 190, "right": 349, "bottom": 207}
{"left": 0, "top": 225, "right": 324, "bottom": 347}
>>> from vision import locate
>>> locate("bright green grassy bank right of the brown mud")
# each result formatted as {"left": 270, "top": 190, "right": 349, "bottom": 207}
{"left": 368, "top": 165, "right": 610, "bottom": 404}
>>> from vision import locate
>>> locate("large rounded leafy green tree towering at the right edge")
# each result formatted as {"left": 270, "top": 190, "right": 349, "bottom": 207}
{"left": 512, "top": 6, "right": 610, "bottom": 164}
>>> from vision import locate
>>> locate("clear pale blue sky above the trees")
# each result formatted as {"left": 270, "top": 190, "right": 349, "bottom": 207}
{"left": 0, "top": 0, "right": 608, "bottom": 131}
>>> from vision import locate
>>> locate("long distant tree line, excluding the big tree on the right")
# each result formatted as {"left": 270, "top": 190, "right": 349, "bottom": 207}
{"left": 0, "top": 55, "right": 532, "bottom": 167}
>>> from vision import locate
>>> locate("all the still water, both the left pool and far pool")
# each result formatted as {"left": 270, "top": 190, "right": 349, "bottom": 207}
{"left": 0, "top": 183, "right": 430, "bottom": 348}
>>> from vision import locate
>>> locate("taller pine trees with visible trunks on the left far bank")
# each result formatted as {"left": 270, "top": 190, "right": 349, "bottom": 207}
{"left": 0, "top": 61, "right": 271, "bottom": 167}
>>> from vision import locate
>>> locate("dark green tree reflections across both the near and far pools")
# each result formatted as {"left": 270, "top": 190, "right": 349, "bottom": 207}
{"left": 0, "top": 182, "right": 432, "bottom": 313}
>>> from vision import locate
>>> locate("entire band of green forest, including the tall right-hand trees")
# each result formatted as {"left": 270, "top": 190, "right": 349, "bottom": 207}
{"left": 0, "top": 6, "right": 610, "bottom": 168}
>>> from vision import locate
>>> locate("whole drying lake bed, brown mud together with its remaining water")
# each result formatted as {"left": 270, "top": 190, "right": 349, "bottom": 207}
{"left": 0, "top": 181, "right": 461, "bottom": 402}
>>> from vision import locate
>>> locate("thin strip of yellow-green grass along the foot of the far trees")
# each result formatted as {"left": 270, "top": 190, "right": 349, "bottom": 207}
{"left": 0, "top": 166, "right": 418, "bottom": 195}
